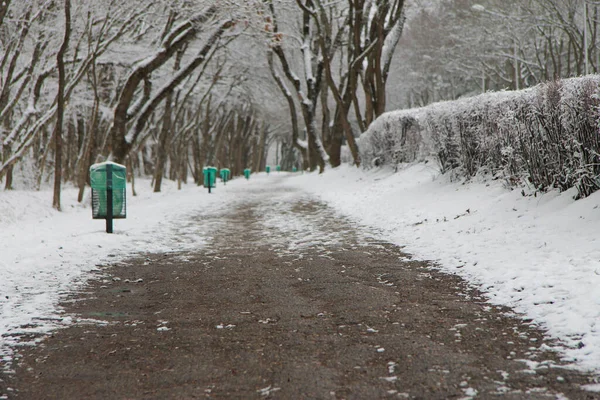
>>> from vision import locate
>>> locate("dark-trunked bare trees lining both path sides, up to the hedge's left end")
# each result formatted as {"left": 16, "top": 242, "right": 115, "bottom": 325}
{"left": 0, "top": 0, "right": 404, "bottom": 209}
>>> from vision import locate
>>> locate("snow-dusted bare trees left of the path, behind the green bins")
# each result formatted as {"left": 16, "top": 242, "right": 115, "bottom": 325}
{"left": 0, "top": 0, "right": 270, "bottom": 209}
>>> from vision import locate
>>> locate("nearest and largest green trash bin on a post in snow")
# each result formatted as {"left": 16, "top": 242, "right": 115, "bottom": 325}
{"left": 90, "top": 161, "right": 127, "bottom": 233}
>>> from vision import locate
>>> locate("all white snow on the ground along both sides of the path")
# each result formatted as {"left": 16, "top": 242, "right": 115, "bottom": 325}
{"left": 0, "top": 162, "right": 600, "bottom": 378}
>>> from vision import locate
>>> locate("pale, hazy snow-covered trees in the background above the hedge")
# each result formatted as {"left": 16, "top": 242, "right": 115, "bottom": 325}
{"left": 388, "top": 0, "right": 600, "bottom": 108}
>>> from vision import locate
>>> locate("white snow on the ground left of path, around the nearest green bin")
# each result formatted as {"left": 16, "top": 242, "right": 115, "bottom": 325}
{"left": 0, "top": 179, "right": 256, "bottom": 368}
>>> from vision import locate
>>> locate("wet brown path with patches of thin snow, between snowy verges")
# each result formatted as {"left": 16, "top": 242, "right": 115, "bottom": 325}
{"left": 0, "top": 180, "right": 598, "bottom": 399}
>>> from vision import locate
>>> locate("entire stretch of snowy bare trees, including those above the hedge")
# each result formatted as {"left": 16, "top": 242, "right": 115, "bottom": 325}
{"left": 0, "top": 0, "right": 600, "bottom": 209}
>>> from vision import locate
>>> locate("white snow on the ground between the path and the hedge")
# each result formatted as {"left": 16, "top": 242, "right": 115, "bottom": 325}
{"left": 289, "top": 162, "right": 600, "bottom": 371}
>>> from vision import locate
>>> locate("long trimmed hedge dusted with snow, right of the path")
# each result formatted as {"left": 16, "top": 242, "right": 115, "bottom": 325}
{"left": 359, "top": 75, "right": 600, "bottom": 197}
